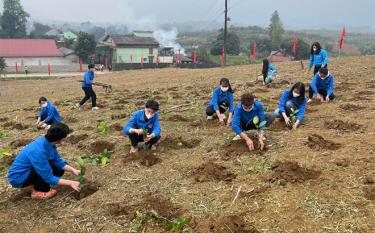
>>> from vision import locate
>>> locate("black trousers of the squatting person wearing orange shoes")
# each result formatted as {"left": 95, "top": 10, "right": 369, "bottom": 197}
{"left": 22, "top": 162, "right": 64, "bottom": 192}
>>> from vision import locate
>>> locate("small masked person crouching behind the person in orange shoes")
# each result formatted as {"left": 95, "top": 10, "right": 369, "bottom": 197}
{"left": 35, "top": 96, "right": 61, "bottom": 129}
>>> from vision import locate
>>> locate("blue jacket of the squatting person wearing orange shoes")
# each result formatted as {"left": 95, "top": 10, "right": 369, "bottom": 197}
{"left": 8, "top": 136, "right": 67, "bottom": 188}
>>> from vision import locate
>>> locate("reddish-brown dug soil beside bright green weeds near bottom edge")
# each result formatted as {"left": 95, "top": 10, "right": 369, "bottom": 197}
{"left": 108, "top": 195, "right": 183, "bottom": 220}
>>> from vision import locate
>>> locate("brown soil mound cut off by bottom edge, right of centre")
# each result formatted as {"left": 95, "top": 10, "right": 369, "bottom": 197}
{"left": 194, "top": 215, "right": 260, "bottom": 233}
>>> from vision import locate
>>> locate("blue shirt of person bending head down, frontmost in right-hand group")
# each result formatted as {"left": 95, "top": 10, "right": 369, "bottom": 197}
{"left": 232, "top": 100, "right": 266, "bottom": 135}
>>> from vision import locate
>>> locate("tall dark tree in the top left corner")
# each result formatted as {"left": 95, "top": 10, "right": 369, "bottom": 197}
{"left": 1, "top": 0, "right": 29, "bottom": 38}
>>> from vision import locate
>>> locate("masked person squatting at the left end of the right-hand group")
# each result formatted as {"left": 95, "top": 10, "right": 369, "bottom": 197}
{"left": 206, "top": 78, "right": 234, "bottom": 127}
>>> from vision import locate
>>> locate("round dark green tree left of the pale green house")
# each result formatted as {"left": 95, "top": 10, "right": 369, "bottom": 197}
{"left": 74, "top": 32, "right": 96, "bottom": 62}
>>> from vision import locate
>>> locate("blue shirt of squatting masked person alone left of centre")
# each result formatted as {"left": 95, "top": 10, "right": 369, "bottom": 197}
{"left": 123, "top": 109, "right": 161, "bottom": 136}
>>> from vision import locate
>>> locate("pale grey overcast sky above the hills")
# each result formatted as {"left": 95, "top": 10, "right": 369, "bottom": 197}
{"left": 0, "top": 0, "right": 375, "bottom": 28}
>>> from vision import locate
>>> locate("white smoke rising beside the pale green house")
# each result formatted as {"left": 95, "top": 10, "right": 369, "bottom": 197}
{"left": 154, "top": 28, "right": 185, "bottom": 55}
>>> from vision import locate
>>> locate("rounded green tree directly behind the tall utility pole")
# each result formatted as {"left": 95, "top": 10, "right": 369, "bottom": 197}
{"left": 211, "top": 29, "right": 241, "bottom": 55}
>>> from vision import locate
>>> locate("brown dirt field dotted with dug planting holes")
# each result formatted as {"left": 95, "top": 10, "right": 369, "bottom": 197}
{"left": 0, "top": 56, "right": 375, "bottom": 233}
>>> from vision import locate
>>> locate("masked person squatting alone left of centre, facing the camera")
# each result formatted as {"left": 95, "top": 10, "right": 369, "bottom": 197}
{"left": 123, "top": 100, "right": 161, "bottom": 154}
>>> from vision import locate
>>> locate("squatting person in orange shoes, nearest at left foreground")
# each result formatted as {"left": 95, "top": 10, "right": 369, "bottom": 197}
{"left": 7, "top": 123, "right": 80, "bottom": 199}
